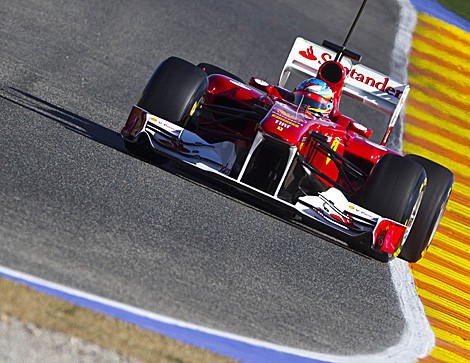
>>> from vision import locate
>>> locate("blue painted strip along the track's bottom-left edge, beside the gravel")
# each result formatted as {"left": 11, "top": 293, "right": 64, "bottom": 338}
{"left": 0, "top": 272, "right": 327, "bottom": 363}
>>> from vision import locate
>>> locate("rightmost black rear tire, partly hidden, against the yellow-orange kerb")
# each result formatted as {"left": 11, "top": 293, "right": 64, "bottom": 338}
{"left": 398, "top": 155, "right": 454, "bottom": 262}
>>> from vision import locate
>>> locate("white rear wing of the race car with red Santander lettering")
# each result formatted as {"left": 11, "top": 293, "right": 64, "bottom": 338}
{"left": 279, "top": 37, "right": 410, "bottom": 145}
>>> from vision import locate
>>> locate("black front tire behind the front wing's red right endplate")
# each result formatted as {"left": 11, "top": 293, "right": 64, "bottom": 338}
{"left": 358, "top": 154, "right": 426, "bottom": 259}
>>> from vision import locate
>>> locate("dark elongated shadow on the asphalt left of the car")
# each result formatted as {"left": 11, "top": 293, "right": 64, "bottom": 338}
{"left": 0, "top": 87, "right": 126, "bottom": 152}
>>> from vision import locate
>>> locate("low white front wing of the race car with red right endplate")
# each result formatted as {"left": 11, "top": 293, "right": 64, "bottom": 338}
{"left": 121, "top": 106, "right": 407, "bottom": 257}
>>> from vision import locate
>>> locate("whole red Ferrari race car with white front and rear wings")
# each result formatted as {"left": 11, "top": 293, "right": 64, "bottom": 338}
{"left": 121, "top": 34, "right": 453, "bottom": 262}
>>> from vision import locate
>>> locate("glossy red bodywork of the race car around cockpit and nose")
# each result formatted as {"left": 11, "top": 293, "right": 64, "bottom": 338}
{"left": 198, "top": 62, "right": 394, "bottom": 191}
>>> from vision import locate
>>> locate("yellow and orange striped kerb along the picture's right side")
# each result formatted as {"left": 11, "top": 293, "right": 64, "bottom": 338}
{"left": 410, "top": 14, "right": 470, "bottom": 363}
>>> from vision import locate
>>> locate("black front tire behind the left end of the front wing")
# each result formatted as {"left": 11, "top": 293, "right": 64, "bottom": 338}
{"left": 137, "top": 57, "right": 207, "bottom": 126}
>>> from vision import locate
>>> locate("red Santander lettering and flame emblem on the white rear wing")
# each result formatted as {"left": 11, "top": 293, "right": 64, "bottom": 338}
{"left": 299, "top": 46, "right": 403, "bottom": 99}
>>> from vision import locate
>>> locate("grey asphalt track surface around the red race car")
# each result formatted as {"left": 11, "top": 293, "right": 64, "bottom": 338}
{"left": 0, "top": 0, "right": 412, "bottom": 354}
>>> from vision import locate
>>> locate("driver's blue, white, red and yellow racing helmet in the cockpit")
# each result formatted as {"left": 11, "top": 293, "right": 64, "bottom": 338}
{"left": 294, "top": 78, "right": 333, "bottom": 116}
